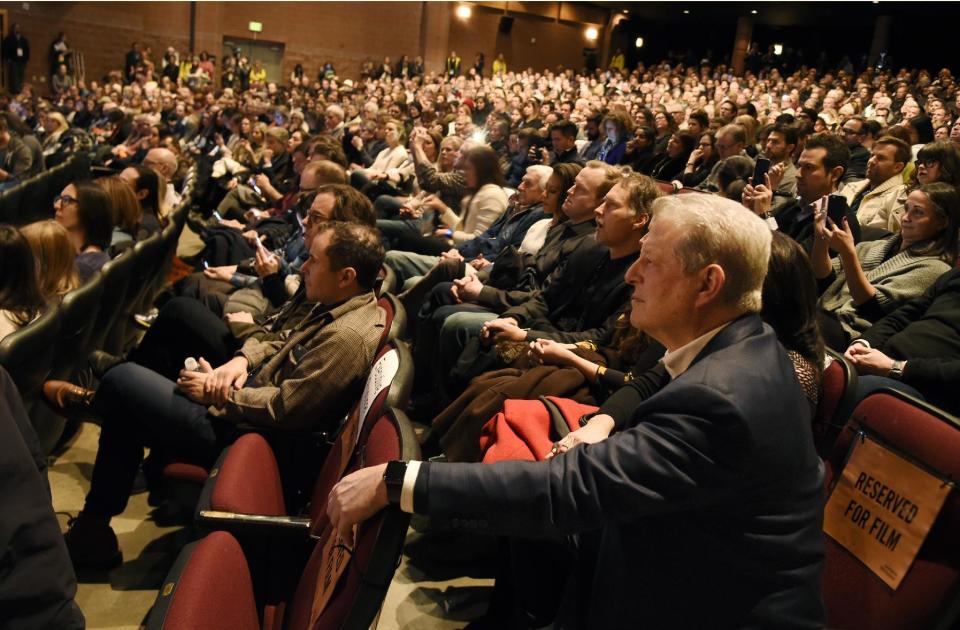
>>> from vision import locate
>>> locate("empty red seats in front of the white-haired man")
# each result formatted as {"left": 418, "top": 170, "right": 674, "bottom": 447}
{"left": 146, "top": 314, "right": 420, "bottom": 630}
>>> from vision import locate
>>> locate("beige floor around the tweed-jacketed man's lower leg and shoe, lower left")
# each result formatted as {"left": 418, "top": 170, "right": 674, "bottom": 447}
{"left": 49, "top": 423, "right": 188, "bottom": 630}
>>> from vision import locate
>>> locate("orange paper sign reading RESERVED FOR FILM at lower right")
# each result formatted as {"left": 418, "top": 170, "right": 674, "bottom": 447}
{"left": 823, "top": 436, "right": 952, "bottom": 590}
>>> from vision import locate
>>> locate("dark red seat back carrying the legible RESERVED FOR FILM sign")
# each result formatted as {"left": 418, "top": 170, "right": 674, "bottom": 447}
{"left": 822, "top": 390, "right": 960, "bottom": 630}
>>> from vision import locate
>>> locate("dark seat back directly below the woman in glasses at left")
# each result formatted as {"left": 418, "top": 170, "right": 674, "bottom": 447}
{"left": 50, "top": 271, "right": 105, "bottom": 380}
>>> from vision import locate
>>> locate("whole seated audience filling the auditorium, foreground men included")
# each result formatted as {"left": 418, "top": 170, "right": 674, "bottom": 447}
{"left": 0, "top": 30, "right": 960, "bottom": 628}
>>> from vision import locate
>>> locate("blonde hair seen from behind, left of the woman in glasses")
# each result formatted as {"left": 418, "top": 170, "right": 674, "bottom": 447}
{"left": 20, "top": 220, "right": 80, "bottom": 300}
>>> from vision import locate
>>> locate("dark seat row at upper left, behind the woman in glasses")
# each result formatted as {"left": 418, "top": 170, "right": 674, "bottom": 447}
{"left": 0, "top": 153, "right": 90, "bottom": 225}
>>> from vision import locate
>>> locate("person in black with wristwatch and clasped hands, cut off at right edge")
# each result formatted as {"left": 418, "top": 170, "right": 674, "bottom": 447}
{"left": 844, "top": 269, "right": 960, "bottom": 414}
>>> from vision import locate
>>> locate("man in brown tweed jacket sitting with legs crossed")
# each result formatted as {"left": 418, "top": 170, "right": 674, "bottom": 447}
{"left": 65, "top": 221, "right": 386, "bottom": 568}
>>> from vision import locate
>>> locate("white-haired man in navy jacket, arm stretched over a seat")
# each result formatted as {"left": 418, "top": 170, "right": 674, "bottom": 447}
{"left": 327, "top": 195, "right": 824, "bottom": 628}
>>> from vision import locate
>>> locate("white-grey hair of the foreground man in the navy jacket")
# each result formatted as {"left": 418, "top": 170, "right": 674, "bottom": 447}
{"left": 653, "top": 194, "right": 772, "bottom": 313}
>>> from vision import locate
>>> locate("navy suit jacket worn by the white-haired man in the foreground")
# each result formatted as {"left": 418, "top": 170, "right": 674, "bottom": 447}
{"left": 414, "top": 315, "right": 824, "bottom": 629}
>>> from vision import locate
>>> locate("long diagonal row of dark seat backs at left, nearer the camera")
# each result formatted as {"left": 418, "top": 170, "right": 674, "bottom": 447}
{"left": 0, "top": 175, "right": 191, "bottom": 452}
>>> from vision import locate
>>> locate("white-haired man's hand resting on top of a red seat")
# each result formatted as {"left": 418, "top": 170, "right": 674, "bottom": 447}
{"left": 327, "top": 464, "right": 389, "bottom": 548}
